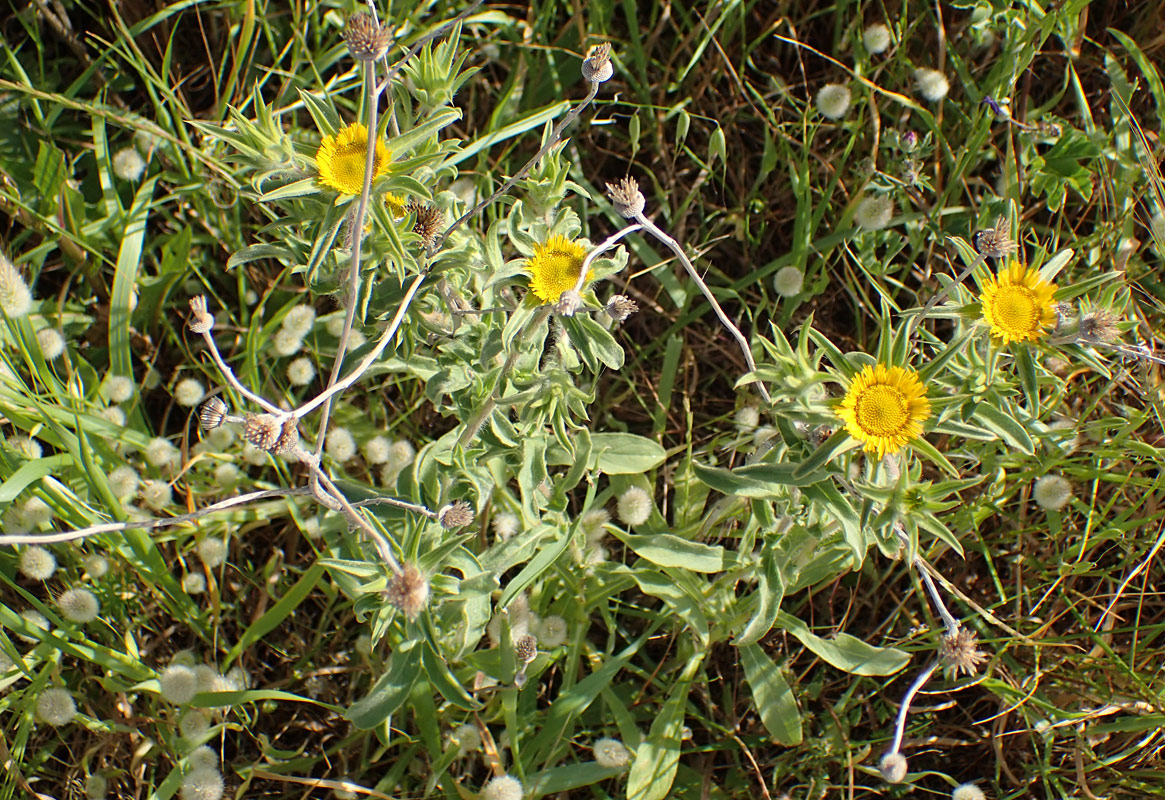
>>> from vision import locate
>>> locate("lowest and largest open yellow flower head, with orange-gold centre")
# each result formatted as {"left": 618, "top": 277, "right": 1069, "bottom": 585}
{"left": 838, "top": 363, "right": 931, "bottom": 458}
